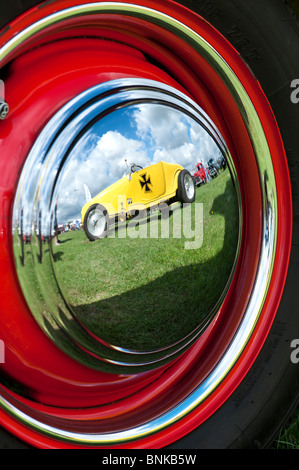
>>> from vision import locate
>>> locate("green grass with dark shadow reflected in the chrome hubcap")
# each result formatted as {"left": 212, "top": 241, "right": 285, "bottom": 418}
{"left": 50, "top": 171, "right": 238, "bottom": 350}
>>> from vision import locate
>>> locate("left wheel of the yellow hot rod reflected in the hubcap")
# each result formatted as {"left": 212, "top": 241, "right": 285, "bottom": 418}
{"left": 84, "top": 204, "right": 109, "bottom": 241}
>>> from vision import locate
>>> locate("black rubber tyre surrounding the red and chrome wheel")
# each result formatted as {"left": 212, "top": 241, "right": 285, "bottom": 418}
{"left": 0, "top": 0, "right": 299, "bottom": 449}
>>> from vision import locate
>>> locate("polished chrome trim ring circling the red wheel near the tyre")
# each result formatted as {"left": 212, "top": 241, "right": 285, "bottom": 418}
{"left": 0, "top": 2, "right": 277, "bottom": 446}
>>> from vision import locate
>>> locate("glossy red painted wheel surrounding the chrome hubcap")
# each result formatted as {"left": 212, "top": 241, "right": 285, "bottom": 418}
{"left": 0, "top": 0, "right": 292, "bottom": 448}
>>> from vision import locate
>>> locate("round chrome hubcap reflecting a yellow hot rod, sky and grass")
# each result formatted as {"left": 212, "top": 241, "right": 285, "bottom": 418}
{"left": 14, "top": 79, "right": 241, "bottom": 373}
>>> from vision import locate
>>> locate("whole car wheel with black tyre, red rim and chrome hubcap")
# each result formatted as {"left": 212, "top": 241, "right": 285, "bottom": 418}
{"left": 0, "top": 0, "right": 299, "bottom": 450}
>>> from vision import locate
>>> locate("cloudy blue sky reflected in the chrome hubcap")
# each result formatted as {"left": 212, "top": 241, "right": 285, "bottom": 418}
{"left": 58, "top": 103, "right": 219, "bottom": 223}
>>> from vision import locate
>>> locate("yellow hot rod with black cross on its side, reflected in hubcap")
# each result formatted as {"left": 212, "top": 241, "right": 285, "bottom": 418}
{"left": 82, "top": 161, "right": 195, "bottom": 241}
